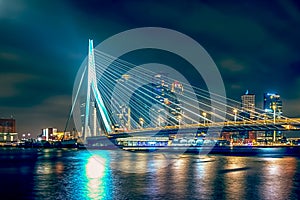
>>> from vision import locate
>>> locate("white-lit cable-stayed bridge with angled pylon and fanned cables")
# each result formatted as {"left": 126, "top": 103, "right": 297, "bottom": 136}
{"left": 70, "top": 40, "right": 300, "bottom": 144}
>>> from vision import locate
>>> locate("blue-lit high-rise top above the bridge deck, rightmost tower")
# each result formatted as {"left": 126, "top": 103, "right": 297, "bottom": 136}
{"left": 264, "top": 93, "right": 282, "bottom": 117}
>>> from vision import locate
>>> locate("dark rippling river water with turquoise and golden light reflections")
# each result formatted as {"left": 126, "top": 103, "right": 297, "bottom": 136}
{"left": 0, "top": 149, "right": 300, "bottom": 199}
